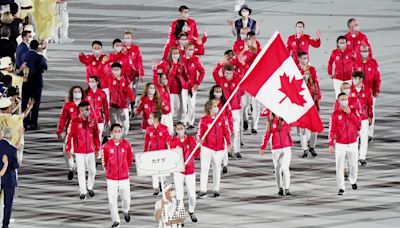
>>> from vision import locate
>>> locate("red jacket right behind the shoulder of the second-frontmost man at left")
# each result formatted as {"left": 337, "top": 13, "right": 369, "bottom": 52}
{"left": 85, "top": 88, "right": 110, "bottom": 123}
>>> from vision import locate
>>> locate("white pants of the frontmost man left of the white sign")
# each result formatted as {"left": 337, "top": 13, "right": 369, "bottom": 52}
{"left": 107, "top": 179, "right": 131, "bottom": 223}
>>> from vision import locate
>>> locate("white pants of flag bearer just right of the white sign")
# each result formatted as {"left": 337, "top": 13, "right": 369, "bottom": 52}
{"left": 174, "top": 173, "right": 196, "bottom": 213}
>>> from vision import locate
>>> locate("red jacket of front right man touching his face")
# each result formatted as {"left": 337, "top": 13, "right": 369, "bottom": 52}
{"left": 328, "top": 109, "right": 361, "bottom": 146}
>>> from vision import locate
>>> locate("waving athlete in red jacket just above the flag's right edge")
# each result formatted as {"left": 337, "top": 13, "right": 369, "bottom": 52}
{"left": 287, "top": 21, "right": 321, "bottom": 64}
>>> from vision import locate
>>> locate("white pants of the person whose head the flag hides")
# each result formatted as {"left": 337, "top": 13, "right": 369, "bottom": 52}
{"left": 272, "top": 147, "right": 292, "bottom": 189}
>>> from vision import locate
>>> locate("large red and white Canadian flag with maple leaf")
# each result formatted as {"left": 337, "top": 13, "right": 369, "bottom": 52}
{"left": 240, "top": 32, "right": 324, "bottom": 132}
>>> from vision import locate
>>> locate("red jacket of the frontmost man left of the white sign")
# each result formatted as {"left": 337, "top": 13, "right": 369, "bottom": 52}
{"left": 103, "top": 139, "right": 133, "bottom": 180}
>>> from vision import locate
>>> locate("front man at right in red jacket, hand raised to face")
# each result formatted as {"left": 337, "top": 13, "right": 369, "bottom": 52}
{"left": 328, "top": 93, "right": 361, "bottom": 195}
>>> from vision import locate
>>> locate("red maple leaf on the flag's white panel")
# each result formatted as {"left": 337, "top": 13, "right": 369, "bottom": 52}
{"left": 279, "top": 73, "right": 307, "bottom": 106}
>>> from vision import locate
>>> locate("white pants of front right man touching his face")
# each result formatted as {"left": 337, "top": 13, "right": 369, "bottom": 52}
{"left": 335, "top": 142, "right": 358, "bottom": 190}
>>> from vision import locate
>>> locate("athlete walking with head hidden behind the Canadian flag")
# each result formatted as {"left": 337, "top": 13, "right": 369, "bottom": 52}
{"left": 259, "top": 112, "right": 293, "bottom": 196}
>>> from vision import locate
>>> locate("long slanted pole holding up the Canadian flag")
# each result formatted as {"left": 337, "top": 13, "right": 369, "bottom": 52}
{"left": 185, "top": 31, "right": 279, "bottom": 166}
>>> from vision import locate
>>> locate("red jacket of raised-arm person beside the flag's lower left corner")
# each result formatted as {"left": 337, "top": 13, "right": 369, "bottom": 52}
{"left": 213, "top": 63, "right": 243, "bottom": 110}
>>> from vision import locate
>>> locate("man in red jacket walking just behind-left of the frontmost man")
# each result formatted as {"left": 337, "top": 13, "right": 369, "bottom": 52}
{"left": 65, "top": 101, "right": 100, "bottom": 200}
